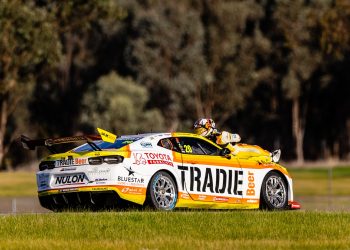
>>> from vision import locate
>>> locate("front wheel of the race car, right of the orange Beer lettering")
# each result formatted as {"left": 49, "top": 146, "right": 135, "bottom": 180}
{"left": 260, "top": 171, "right": 288, "bottom": 210}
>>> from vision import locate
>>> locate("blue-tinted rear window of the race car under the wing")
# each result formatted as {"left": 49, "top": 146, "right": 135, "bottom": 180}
{"left": 73, "top": 137, "right": 143, "bottom": 153}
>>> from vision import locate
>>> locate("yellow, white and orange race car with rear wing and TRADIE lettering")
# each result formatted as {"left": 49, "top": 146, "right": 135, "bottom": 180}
{"left": 22, "top": 129, "right": 300, "bottom": 210}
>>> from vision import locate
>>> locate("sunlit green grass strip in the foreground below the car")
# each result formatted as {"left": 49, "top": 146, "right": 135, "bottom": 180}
{"left": 0, "top": 211, "right": 350, "bottom": 249}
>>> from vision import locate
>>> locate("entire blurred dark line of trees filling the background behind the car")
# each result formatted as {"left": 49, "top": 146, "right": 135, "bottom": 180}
{"left": 0, "top": 0, "right": 350, "bottom": 169}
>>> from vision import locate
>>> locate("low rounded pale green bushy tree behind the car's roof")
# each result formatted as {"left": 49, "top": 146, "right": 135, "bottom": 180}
{"left": 81, "top": 72, "right": 164, "bottom": 135}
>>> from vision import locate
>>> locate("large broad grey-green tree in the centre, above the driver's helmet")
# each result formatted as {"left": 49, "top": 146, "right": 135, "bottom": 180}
{"left": 126, "top": 0, "right": 271, "bottom": 129}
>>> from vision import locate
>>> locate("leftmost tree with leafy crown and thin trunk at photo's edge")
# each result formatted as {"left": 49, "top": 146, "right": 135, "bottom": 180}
{"left": 0, "top": 0, "right": 61, "bottom": 170}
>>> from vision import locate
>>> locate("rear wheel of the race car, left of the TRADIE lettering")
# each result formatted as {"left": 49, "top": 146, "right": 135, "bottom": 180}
{"left": 148, "top": 171, "right": 178, "bottom": 210}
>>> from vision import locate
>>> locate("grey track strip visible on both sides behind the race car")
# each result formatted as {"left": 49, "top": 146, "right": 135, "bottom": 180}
{"left": 0, "top": 196, "right": 350, "bottom": 215}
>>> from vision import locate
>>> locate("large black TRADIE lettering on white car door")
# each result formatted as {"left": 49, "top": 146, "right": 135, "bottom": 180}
{"left": 178, "top": 166, "right": 243, "bottom": 195}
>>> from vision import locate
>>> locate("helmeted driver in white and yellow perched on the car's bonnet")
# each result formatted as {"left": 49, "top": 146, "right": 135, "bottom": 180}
{"left": 194, "top": 118, "right": 281, "bottom": 163}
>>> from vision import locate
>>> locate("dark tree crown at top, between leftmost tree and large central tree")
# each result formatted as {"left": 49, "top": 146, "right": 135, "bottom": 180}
{"left": 44, "top": 0, "right": 126, "bottom": 90}
